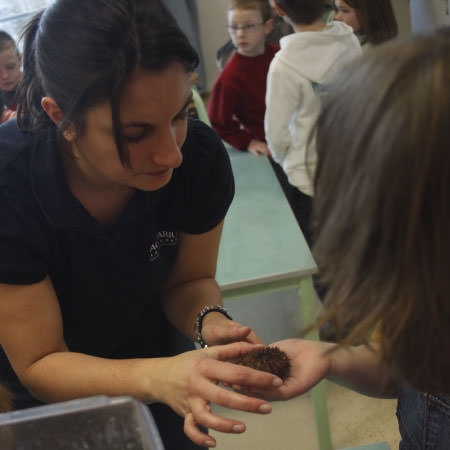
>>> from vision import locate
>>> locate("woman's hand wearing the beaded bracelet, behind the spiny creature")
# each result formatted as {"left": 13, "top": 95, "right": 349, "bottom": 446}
{"left": 202, "top": 312, "right": 263, "bottom": 346}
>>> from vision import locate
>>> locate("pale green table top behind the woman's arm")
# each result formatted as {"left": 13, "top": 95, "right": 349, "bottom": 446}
{"left": 216, "top": 148, "right": 316, "bottom": 291}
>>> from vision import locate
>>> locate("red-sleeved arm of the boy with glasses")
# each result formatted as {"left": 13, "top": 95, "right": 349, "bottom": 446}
{"left": 208, "top": 78, "right": 253, "bottom": 151}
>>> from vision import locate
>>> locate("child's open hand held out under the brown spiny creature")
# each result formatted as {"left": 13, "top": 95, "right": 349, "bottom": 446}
{"left": 240, "top": 339, "right": 334, "bottom": 400}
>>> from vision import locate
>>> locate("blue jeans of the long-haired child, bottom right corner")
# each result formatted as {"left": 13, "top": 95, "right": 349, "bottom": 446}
{"left": 397, "top": 388, "right": 450, "bottom": 450}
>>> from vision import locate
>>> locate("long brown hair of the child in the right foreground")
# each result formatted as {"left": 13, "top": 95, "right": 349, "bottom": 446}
{"left": 314, "top": 29, "right": 450, "bottom": 394}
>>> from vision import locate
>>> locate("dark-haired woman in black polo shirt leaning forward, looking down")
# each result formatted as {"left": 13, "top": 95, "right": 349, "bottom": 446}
{"left": 0, "top": 0, "right": 281, "bottom": 450}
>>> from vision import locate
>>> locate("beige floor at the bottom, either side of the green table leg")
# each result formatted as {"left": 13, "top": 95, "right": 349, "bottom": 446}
{"left": 213, "top": 383, "right": 400, "bottom": 450}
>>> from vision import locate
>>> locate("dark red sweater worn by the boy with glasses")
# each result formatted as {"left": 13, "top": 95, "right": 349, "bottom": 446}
{"left": 208, "top": 44, "right": 279, "bottom": 150}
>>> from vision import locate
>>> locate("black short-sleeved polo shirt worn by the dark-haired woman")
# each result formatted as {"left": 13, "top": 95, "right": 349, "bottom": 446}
{"left": 0, "top": 120, "right": 234, "bottom": 398}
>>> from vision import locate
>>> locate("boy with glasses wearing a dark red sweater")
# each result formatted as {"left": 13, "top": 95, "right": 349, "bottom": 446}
{"left": 208, "top": 0, "right": 279, "bottom": 155}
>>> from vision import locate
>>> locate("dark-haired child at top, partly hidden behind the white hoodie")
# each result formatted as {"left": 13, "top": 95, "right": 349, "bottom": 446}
{"left": 335, "top": 0, "right": 398, "bottom": 47}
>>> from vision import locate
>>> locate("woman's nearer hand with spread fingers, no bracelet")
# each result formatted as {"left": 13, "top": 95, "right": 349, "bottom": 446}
{"left": 155, "top": 342, "right": 282, "bottom": 447}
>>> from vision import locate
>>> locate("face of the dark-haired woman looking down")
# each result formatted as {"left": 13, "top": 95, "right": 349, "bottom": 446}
{"left": 64, "top": 63, "right": 191, "bottom": 191}
